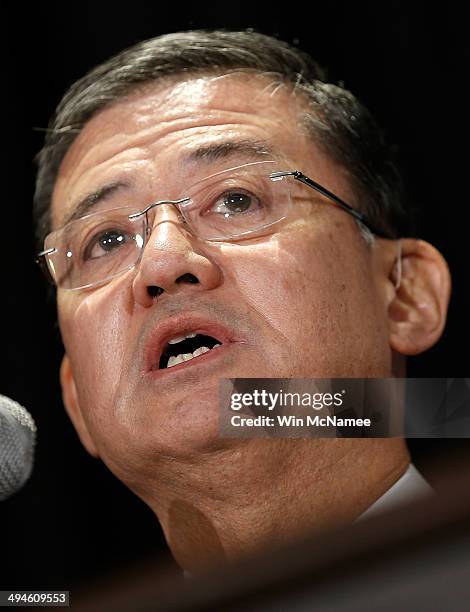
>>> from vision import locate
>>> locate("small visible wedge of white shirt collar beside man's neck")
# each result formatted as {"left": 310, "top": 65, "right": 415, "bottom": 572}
{"left": 355, "top": 463, "right": 435, "bottom": 522}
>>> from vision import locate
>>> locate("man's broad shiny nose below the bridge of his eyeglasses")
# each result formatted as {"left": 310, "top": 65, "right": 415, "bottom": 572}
{"left": 132, "top": 204, "right": 222, "bottom": 307}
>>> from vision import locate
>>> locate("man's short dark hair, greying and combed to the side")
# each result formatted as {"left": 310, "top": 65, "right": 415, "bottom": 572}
{"left": 34, "top": 30, "right": 410, "bottom": 249}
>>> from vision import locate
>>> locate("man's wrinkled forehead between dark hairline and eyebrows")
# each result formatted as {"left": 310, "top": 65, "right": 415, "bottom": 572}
{"left": 52, "top": 74, "right": 342, "bottom": 228}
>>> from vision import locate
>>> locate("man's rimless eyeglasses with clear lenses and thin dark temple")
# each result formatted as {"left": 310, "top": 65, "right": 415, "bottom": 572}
{"left": 36, "top": 161, "right": 391, "bottom": 290}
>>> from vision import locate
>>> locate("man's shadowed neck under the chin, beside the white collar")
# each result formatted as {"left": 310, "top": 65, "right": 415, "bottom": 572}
{"left": 145, "top": 438, "right": 410, "bottom": 574}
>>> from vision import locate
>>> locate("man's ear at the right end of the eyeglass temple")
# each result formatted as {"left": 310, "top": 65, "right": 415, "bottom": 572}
{"left": 388, "top": 238, "right": 451, "bottom": 355}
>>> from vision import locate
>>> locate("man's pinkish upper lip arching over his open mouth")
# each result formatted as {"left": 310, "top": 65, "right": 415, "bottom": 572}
{"left": 143, "top": 313, "right": 236, "bottom": 372}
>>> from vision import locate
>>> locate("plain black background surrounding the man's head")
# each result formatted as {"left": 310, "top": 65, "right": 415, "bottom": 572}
{"left": 0, "top": 0, "right": 470, "bottom": 589}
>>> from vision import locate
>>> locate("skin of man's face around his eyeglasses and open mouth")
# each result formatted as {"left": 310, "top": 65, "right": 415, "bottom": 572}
{"left": 52, "top": 75, "right": 391, "bottom": 482}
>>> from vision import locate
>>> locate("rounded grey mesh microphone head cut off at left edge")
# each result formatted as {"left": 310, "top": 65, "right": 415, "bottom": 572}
{"left": 0, "top": 394, "right": 36, "bottom": 501}
